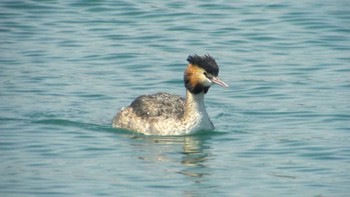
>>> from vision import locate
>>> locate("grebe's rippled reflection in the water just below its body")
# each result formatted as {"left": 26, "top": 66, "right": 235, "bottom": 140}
{"left": 133, "top": 134, "right": 211, "bottom": 181}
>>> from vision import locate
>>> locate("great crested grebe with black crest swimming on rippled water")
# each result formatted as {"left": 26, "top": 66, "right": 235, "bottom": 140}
{"left": 112, "top": 55, "right": 228, "bottom": 135}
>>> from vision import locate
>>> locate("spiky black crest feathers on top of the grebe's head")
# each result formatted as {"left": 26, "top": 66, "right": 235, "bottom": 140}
{"left": 187, "top": 54, "right": 219, "bottom": 76}
